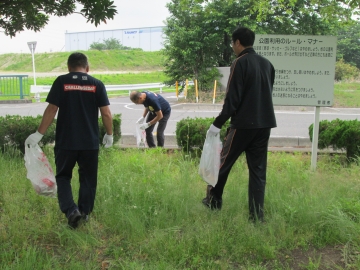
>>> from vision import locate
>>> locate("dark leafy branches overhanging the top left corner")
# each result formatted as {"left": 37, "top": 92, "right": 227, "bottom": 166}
{"left": 0, "top": 0, "right": 117, "bottom": 37}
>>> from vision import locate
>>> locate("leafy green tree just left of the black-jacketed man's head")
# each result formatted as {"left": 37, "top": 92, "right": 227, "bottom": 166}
{"left": 164, "top": 0, "right": 225, "bottom": 89}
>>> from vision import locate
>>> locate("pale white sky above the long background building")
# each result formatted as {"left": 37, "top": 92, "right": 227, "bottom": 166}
{"left": 0, "top": 0, "right": 170, "bottom": 54}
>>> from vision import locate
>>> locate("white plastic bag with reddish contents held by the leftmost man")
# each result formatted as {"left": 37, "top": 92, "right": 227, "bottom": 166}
{"left": 24, "top": 144, "right": 57, "bottom": 197}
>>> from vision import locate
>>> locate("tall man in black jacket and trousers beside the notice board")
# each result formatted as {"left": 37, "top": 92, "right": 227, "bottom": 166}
{"left": 203, "top": 27, "right": 276, "bottom": 221}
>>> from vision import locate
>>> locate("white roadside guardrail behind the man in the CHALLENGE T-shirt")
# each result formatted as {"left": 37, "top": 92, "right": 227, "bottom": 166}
{"left": 30, "top": 83, "right": 165, "bottom": 102}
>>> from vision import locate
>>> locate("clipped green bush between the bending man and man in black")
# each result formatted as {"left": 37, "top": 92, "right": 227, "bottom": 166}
{"left": 175, "top": 117, "right": 228, "bottom": 152}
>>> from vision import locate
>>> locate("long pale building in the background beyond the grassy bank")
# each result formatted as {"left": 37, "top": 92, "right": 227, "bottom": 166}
{"left": 65, "top": 26, "right": 165, "bottom": 52}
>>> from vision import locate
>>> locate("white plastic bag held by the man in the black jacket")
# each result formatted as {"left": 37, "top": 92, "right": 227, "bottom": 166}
{"left": 199, "top": 134, "right": 222, "bottom": 187}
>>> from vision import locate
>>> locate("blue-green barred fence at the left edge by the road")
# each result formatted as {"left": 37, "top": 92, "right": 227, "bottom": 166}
{"left": 0, "top": 75, "right": 30, "bottom": 99}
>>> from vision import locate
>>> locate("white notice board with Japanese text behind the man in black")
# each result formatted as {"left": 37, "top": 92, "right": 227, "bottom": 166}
{"left": 254, "top": 35, "right": 337, "bottom": 107}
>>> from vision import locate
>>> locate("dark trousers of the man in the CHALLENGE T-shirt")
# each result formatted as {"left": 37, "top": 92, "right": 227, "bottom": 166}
{"left": 54, "top": 147, "right": 99, "bottom": 217}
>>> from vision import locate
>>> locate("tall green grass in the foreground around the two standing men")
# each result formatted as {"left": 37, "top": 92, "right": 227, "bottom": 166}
{"left": 0, "top": 148, "right": 360, "bottom": 269}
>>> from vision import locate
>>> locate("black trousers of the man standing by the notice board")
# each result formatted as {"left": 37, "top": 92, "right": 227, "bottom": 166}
{"left": 212, "top": 128, "right": 271, "bottom": 219}
